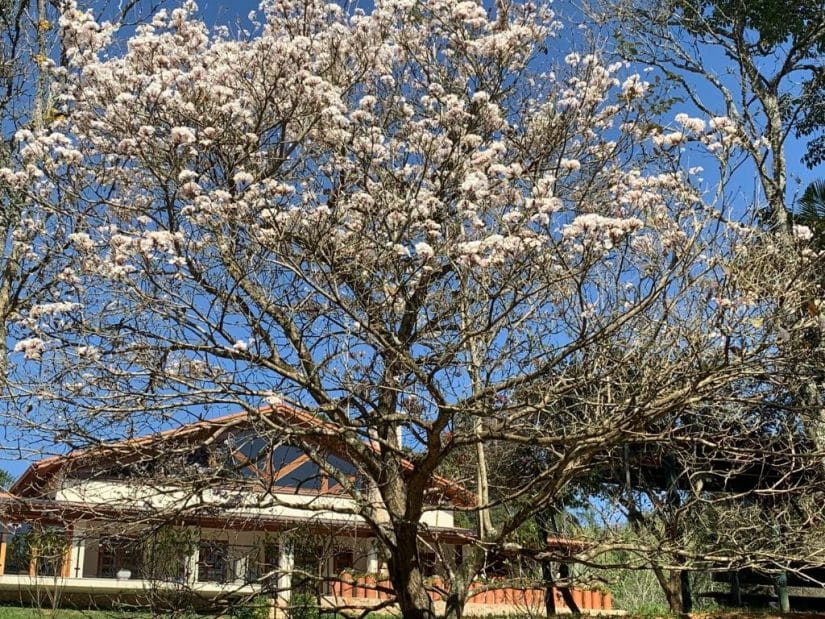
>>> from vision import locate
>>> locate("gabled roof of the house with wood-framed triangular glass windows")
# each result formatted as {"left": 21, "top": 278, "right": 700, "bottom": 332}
{"left": 10, "top": 404, "right": 476, "bottom": 507}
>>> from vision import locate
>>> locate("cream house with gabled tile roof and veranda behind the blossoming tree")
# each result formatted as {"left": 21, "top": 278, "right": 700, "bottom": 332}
{"left": 0, "top": 405, "right": 609, "bottom": 612}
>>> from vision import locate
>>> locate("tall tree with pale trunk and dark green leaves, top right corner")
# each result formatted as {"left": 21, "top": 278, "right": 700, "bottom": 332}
{"left": 602, "top": 0, "right": 825, "bottom": 223}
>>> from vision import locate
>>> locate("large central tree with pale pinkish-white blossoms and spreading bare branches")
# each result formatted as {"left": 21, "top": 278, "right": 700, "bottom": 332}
{"left": 10, "top": 0, "right": 806, "bottom": 617}
